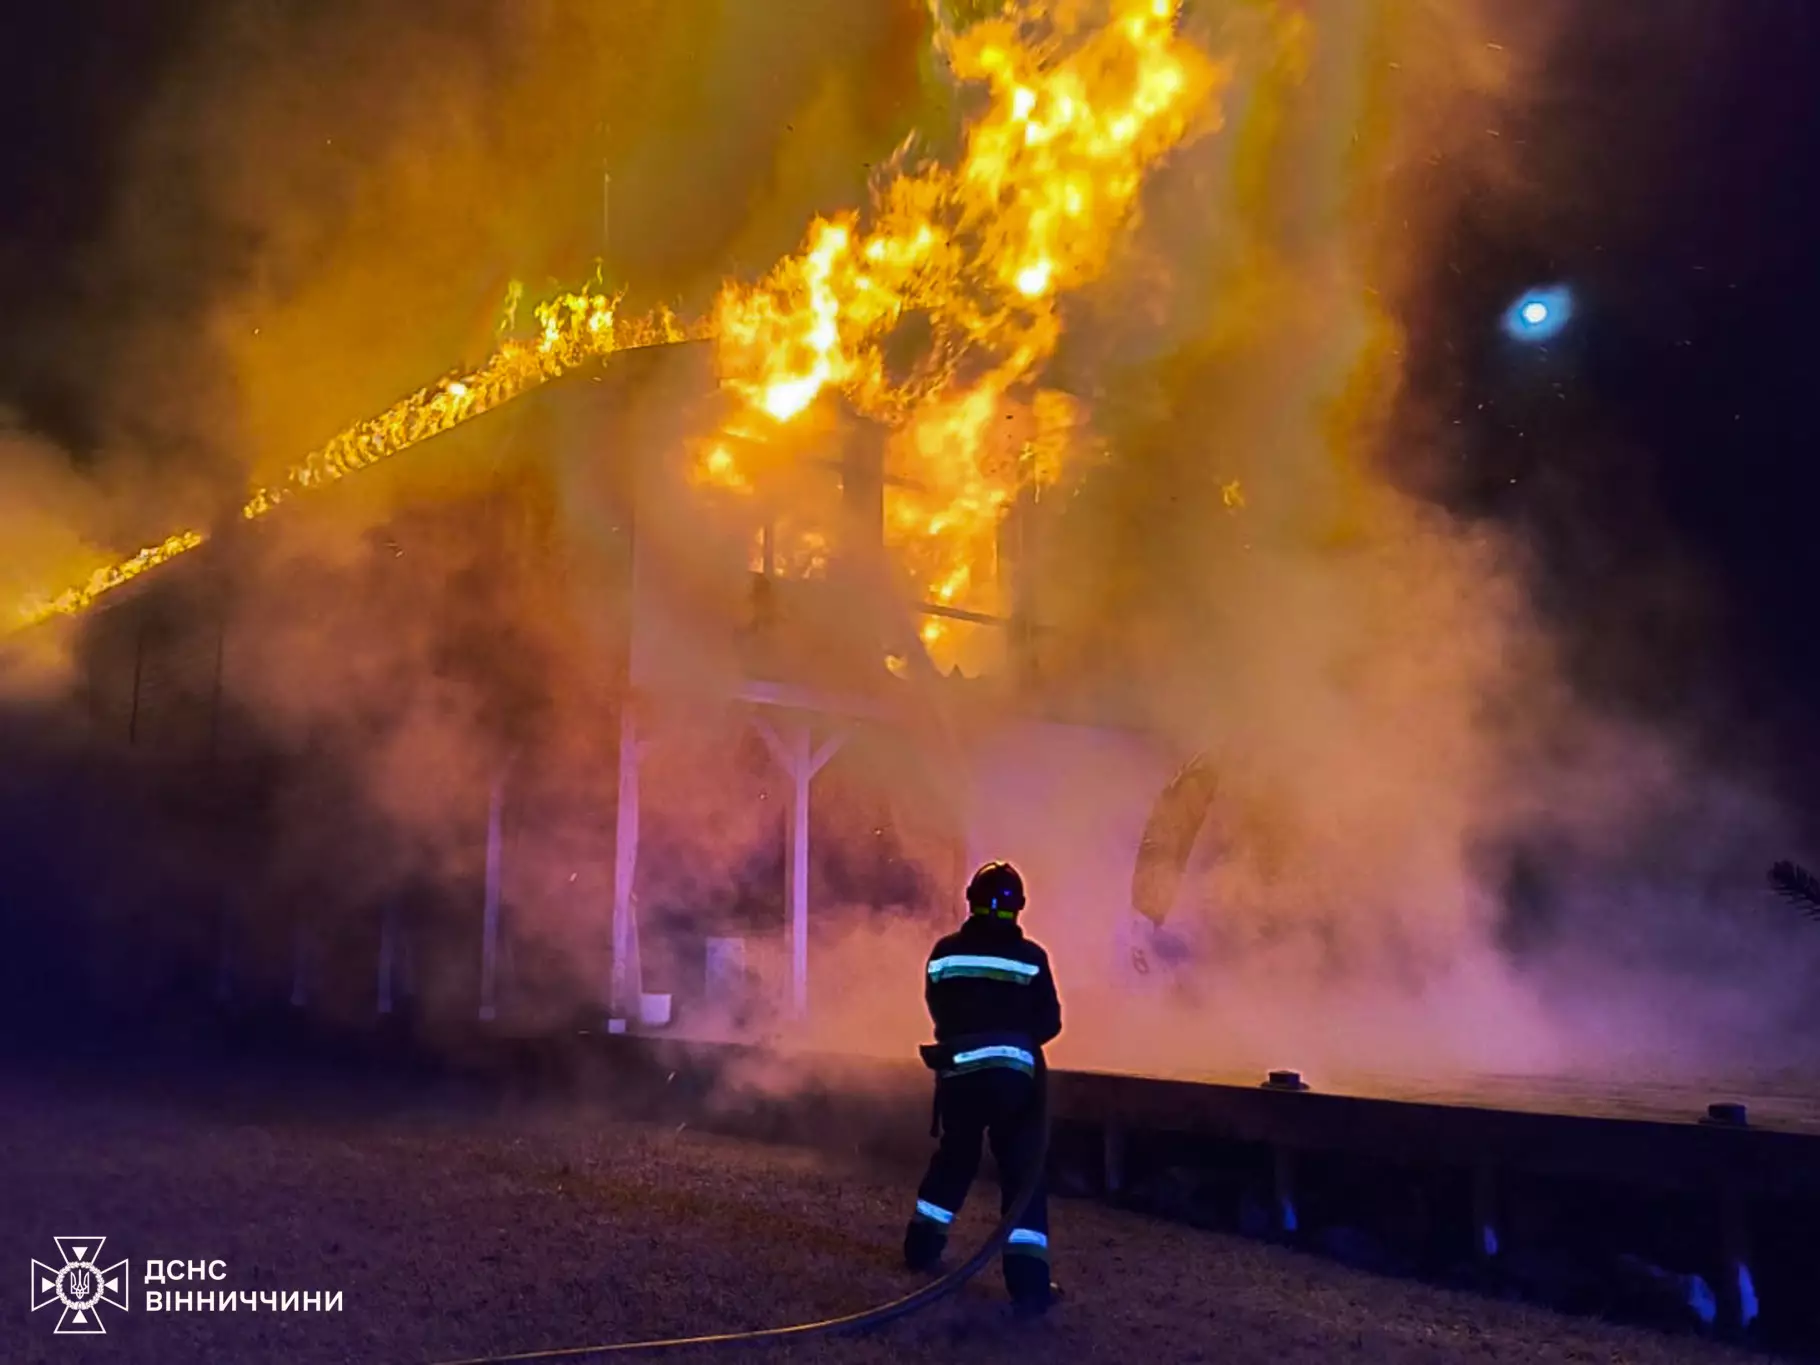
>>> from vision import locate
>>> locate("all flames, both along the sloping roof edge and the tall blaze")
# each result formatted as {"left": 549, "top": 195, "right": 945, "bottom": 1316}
{"left": 16, "top": 0, "right": 1223, "bottom": 658}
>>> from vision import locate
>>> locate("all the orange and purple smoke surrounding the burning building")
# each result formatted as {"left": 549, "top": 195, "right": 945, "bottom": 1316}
{"left": 0, "top": 0, "right": 1811, "bottom": 1085}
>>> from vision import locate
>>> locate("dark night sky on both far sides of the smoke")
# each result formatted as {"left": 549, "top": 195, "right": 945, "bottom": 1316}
{"left": 10, "top": 0, "right": 1820, "bottom": 806}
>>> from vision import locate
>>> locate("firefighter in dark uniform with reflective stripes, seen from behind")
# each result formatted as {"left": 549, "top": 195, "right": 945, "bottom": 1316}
{"left": 905, "top": 863, "right": 1061, "bottom": 1312}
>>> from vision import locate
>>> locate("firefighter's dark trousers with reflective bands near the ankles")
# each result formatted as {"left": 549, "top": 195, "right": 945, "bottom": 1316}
{"left": 905, "top": 1067, "right": 1048, "bottom": 1299}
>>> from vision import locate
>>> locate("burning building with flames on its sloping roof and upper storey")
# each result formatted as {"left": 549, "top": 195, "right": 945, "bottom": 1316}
{"left": 3, "top": 0, "right": 1252, "bottom": 1055}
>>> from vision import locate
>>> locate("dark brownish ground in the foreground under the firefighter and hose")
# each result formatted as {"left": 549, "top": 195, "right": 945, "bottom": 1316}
{"left": 0, "top": 1077, "right": 1783, "bottom": 1365}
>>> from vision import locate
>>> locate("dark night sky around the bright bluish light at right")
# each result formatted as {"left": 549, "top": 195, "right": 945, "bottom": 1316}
{"left": 1411, "top": 0, "right": 1820, "bottom": 808}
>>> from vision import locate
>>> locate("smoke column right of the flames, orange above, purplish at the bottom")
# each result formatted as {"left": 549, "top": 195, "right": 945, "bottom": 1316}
{"left": 713, "top": 5, "right": 1815, "bottom": 1079}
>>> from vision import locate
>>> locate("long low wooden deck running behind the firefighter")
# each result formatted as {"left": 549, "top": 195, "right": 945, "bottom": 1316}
{"left": 613, "top": 1037, "right": 1820, "bottom": 1196}
